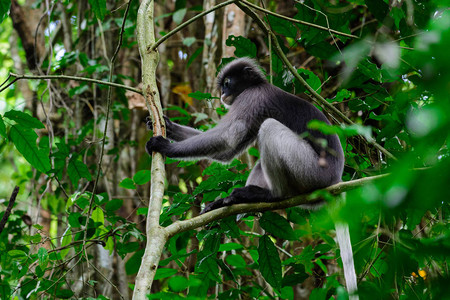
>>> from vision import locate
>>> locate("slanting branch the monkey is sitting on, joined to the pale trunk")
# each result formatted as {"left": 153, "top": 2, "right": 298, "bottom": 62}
{"left": 164, "top": 174, "right": 389, "bottom": 238}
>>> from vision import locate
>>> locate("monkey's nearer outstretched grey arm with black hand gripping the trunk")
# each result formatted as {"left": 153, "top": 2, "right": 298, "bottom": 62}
{"left": 145, "top": 120, "right": 256, "bottom": 162}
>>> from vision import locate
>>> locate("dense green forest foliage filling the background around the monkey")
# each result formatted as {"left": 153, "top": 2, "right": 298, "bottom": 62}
{"left": 0, "top": 0, "right": 450, "bottom": 299}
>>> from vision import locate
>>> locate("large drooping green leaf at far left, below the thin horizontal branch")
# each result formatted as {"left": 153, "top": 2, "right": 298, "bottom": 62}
{"left": 9, "top": 125, "right": 51, "bottom": 173}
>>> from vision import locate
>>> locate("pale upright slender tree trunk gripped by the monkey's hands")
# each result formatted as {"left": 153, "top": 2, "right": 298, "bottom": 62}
{"left": 133, "top": 0, "right": 168, "bottom": 300}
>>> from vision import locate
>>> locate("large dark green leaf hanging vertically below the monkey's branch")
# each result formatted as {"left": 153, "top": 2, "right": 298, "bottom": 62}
{"left": 258, "top": 235, "right": 282, "bottom": 291}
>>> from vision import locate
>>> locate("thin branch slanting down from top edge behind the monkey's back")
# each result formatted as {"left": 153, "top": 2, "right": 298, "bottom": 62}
{"left": 236, "top": 2, "right": 396, "bottom": 160}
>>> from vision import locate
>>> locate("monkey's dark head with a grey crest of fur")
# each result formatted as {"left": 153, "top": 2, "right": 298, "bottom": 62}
{"left": 217, "top": 57, "right": 266, "bottom": 107}
